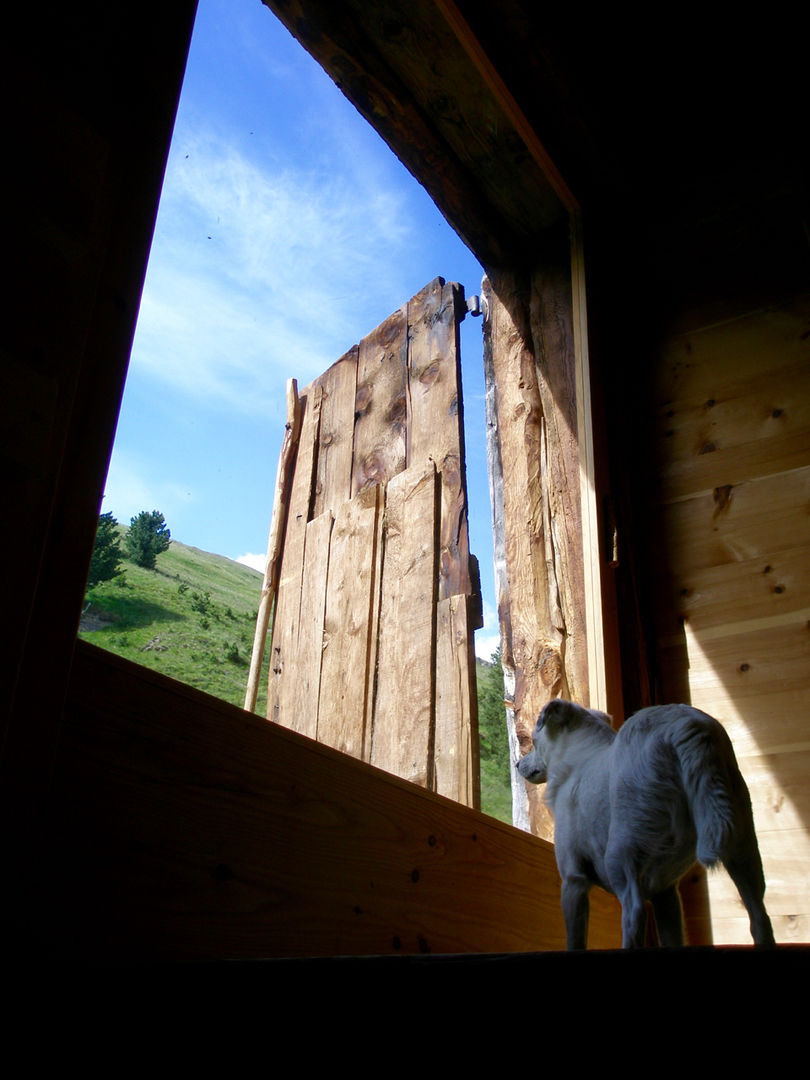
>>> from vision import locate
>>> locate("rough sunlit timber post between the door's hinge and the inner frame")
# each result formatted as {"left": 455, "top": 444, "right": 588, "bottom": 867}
{"left": 483, "top": 232, "right": 591, "bottom": 838}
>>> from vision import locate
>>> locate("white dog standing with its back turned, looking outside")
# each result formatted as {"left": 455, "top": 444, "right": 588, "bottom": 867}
{"left": 517, "top": 700, "right": 773, "bottom": 949}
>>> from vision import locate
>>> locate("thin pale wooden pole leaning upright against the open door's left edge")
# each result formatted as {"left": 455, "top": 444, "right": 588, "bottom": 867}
{"left": 245, "top": 379, "right": 301, "bottom": 713}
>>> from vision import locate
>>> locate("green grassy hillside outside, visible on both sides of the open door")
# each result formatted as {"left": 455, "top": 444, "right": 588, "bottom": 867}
{"left": 79, "top": 530, "right": 512, "bottom": 822}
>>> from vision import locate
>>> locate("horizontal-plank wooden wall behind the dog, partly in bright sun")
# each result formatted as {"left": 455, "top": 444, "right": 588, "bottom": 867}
{"left": 651, "top": 296, "right": 810, "bottom": 944}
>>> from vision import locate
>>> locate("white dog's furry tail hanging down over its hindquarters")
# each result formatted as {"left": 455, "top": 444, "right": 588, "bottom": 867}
{"left": 673, "top": 708, "right": 751, "bottom": 867}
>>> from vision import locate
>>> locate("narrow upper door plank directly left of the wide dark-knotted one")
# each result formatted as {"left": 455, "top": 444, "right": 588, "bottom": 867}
{"left": 312, "top": 346, "right": 357, "bottom": 517}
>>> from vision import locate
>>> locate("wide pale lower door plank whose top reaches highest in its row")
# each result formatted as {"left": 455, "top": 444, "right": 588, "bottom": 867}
{"left": 372, "top": 463, "right": 437, "bottom": 787}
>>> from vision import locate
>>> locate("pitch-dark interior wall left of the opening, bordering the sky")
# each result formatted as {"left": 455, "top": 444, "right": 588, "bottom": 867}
{"left": 0, "top": 0, "right": 195, "bottom": 946}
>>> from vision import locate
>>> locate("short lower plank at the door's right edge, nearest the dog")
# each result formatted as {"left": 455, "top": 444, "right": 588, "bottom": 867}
{"left": 433, "top": 595, "right": 481, "bottom": 809}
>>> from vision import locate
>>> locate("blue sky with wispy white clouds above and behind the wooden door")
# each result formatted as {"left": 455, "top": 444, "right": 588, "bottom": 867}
{"left": 102, "top": 0, "right": 497, "bottom": 659}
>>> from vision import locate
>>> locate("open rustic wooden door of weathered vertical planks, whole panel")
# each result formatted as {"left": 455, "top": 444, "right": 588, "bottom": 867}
{"left": 246, "top": 278, "right": 481, "bottom": 806}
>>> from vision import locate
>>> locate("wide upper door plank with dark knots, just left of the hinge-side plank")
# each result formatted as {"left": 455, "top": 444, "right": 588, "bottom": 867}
{"left": 352, "top": 306, "right": 408, "bottom": 495}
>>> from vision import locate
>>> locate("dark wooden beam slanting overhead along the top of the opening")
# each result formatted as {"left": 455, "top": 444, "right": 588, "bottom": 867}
{"left": 264, "top": 0, "right": 576, "bottom": 269}
